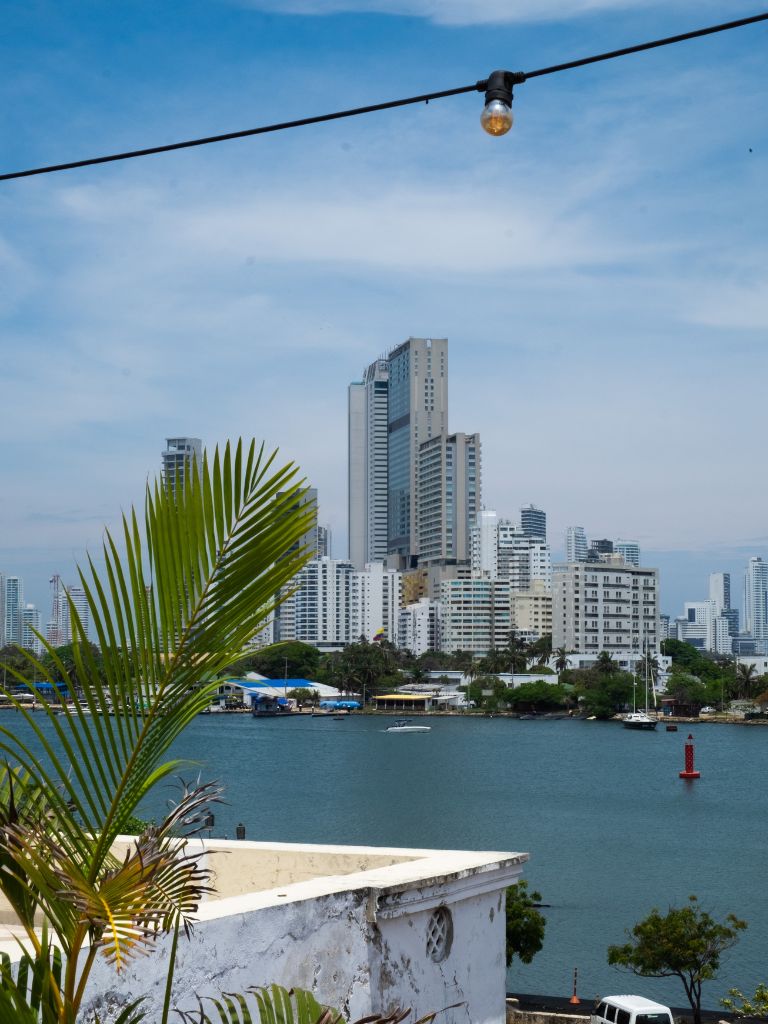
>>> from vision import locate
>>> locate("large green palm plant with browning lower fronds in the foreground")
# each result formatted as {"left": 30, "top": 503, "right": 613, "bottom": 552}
{"left": 0, "top": 443, "right": 313, "bottom": 1024}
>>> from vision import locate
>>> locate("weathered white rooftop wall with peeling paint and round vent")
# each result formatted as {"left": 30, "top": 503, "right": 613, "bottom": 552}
{"left": 66, "top": 844, "right": 527, "bottom": 1024}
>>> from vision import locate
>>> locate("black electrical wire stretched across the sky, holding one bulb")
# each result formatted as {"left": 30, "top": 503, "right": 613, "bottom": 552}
{"left": 0, "top": 11, "right": 768, "bottom": 181}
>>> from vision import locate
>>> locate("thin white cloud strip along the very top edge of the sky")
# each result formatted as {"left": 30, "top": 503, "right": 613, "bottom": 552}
{"left": 231, "top": 0, "right": 700, "bottom": 26}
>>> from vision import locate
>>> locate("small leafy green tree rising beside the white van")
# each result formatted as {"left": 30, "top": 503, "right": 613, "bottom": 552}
{"left": 608, "top": 896, "right": 746, "bottom": 1024}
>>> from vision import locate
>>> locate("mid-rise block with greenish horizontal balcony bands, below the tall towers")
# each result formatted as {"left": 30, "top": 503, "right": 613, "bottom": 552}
{"left": 440, "top": 577, "right": 512, "bottom": 657}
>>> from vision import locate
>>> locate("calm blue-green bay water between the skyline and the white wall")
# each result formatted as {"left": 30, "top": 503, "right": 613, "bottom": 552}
{"left": 3, "top": 716, "right": 768, "bottom": 1007}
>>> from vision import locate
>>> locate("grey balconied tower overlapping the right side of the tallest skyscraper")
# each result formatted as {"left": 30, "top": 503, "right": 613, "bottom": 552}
{"left": 417, "top": 433, "right": 480, "bottom": 565}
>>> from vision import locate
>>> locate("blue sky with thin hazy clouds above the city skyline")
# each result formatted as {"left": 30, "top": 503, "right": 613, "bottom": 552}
{"left": 0, "top": 0, "right": 768, "bottom": 620}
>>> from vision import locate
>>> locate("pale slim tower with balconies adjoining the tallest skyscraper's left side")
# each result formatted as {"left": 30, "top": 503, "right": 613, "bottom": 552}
{"left": 347, "top": 358, "right": 389, "bottom": 568}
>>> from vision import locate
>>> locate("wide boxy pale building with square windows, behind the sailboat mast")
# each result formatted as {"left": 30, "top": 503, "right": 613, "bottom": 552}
{"left": 552, "top": 556, "right": 658, "bottom": 654}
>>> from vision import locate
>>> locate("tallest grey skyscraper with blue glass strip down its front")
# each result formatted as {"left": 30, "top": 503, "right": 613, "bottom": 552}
{"left": 387, "top": 338, "right": 447, "bottom": 568}
